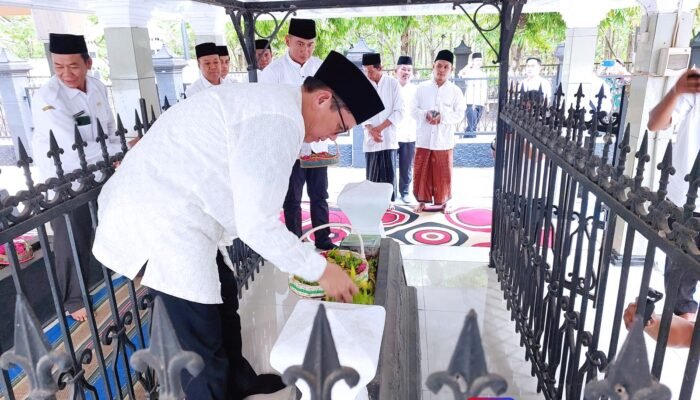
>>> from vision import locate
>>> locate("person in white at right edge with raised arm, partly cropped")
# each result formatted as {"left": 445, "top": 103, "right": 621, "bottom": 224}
{"left": 648, "top": 68, "right": 700, "bottom": 321}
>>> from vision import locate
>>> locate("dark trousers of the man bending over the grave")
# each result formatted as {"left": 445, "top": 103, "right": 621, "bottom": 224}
{"left": 152, "top": 253, "right": 257, "bottom": 400}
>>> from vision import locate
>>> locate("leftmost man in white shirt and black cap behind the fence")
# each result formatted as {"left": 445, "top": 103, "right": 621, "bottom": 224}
{"left": 32, "top": 33, "right": 126, "bottom": 321}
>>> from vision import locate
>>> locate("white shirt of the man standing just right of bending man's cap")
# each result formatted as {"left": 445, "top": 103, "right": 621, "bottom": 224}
{"left": 362, "top": 75, "right": 406, "bottom": 153}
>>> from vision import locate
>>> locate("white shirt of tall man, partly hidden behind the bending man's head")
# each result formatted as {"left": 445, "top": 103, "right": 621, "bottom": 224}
{"left": 258, "top": 50, "right": 328, "bottom": 156}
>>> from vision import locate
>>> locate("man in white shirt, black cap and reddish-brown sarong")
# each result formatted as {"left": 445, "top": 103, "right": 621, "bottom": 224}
{"left": 413, "top": 50, "right": 467, "bottom": 214}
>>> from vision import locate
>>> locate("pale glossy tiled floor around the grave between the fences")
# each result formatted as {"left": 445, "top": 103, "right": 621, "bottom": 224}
{"left": 240, "top": 246, "right": 542, "bottom": 400}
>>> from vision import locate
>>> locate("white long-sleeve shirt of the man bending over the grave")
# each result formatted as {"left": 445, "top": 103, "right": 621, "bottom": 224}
{"left": 93, "top": 83, "right": 326, "bottom": 304}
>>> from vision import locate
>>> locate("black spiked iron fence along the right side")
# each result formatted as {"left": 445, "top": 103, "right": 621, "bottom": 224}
{"left": 491, "top": 86, "right": 700, "bottom": 400}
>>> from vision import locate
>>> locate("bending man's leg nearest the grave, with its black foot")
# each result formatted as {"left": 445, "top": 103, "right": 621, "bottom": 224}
{"left": 216, "top": 253, "right": 285, "bottom": 400}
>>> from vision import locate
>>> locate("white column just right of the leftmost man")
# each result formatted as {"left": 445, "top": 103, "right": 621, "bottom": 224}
{"left": 95, "top": 0, "right": 160, "bottom": 131}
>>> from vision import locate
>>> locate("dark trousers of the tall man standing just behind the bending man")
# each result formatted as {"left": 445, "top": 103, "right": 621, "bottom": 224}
{"left": 283, "top": 160, "right": 331, "bottom": 246}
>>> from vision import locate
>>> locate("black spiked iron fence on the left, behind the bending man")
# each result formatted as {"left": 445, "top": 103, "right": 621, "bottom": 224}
{"left": 0, "top": 99, "right": 263, "bottom": 399}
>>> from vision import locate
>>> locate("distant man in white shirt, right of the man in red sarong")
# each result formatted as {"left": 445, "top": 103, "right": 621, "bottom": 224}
{"left": 459, "top": 53, "right": 488, "bottom": 138}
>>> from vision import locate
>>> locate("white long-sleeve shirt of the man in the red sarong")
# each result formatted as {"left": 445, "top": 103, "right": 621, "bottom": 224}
{"left": 412, "top": 79, "right": 467, "bottom": 150}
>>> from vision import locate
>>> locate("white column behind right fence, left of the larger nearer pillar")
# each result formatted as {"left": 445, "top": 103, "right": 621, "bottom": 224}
{"left": 553, "top": 0, "right": 610, "bottom": 103}
